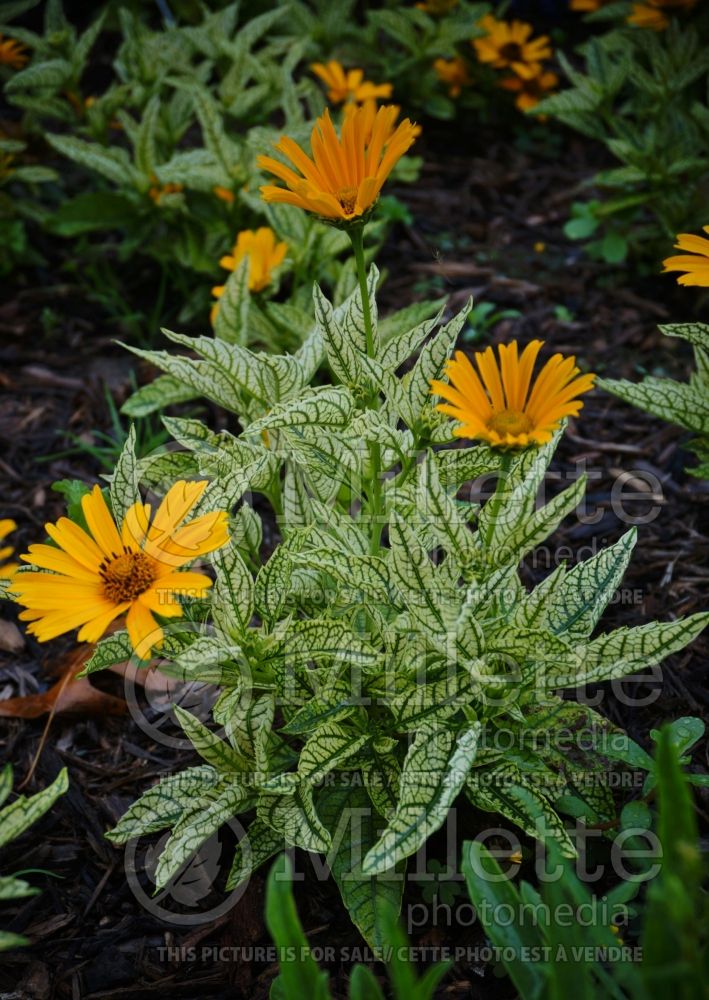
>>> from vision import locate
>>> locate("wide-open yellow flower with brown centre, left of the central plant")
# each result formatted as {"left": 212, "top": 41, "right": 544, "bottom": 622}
{"left": 12, "top": 480, "right": 229, "bottom": 659}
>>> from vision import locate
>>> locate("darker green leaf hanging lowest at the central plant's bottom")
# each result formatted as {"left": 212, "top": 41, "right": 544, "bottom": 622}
{"left": 318, "top": 785, "right": 405, "bottom": 953}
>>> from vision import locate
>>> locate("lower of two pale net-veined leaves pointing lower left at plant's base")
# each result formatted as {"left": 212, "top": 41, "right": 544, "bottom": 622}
{"left": 155, "top": 781, "right": 249, "bottom": 889}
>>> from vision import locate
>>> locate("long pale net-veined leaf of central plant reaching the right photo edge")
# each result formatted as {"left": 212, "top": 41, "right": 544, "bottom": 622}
{"left": 543, "top": 612, "right": 709, "bottom": 688}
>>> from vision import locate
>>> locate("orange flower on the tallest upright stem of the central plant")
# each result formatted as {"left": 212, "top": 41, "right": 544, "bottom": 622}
{"left": 257, "top": 105, "right": 416, "bottom": 223}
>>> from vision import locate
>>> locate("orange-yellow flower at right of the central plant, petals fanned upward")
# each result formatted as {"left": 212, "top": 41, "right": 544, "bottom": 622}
{"left": 431, "top": 340, "right": 595, "bottom": 448}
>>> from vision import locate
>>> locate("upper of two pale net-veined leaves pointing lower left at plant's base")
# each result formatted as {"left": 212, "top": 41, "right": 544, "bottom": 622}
{"left": 106, "top": 764, "right": 219, "bottom": 844}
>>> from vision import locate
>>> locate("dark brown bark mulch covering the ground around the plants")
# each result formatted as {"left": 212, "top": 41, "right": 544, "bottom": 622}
{"left": 0, "top": 121, "right": 709, "bottom": 1000}
